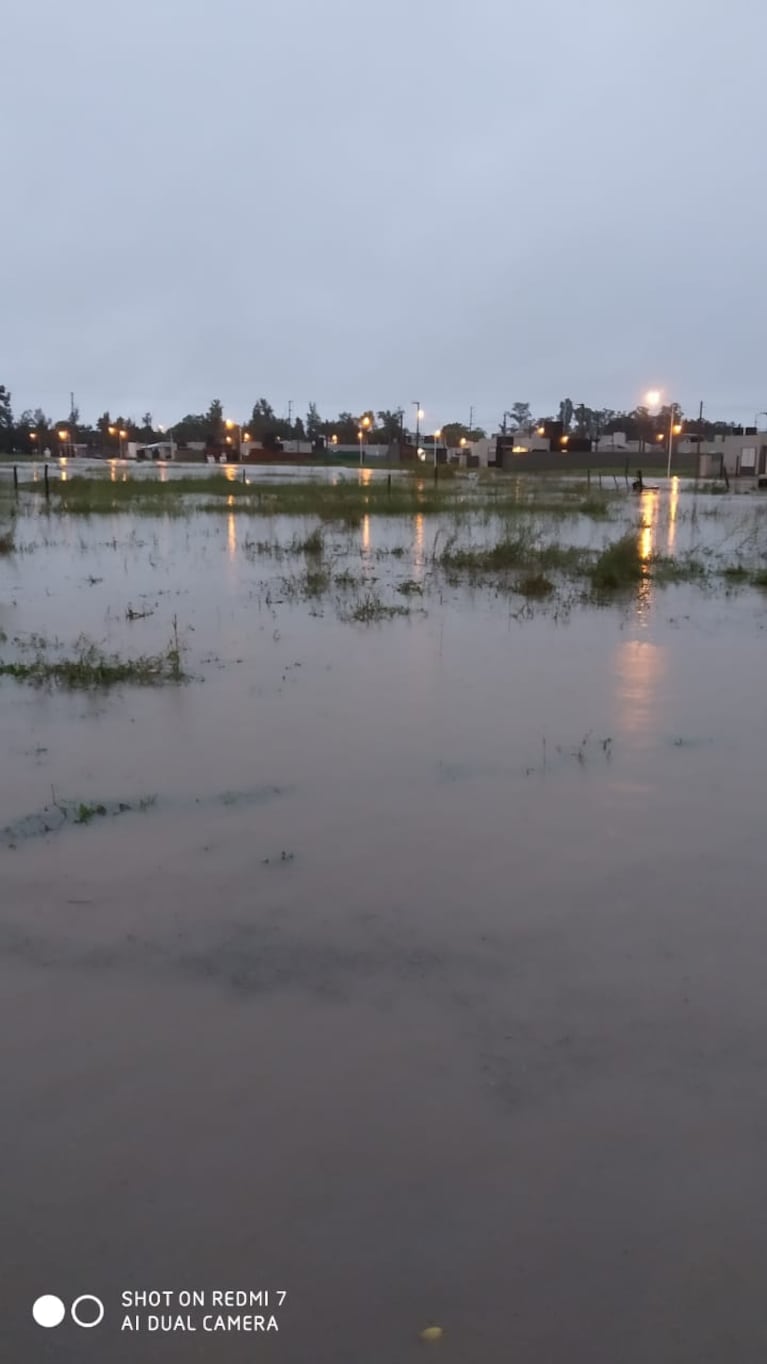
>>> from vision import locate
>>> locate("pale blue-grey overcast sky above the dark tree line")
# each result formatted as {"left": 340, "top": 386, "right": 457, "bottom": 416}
{"left": 0, "top": 0, "right": 767, "bottom": 430}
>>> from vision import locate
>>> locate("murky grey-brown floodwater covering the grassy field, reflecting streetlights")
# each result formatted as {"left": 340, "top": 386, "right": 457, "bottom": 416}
{"left": 0, "top": 474, "right": 767, "bottom": 1364}
